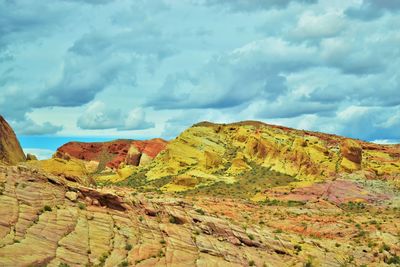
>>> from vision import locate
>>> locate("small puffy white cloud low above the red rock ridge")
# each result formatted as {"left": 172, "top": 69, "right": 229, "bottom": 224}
{"left": 77, "top": 101, "right": 155, "bottom": 131}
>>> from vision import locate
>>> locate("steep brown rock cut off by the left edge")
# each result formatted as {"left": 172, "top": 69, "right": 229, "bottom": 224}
{"left": 0, "top": 116, "right": 26, "bottom": 164}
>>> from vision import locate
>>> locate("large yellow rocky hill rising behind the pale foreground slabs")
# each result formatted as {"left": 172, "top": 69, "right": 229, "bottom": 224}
{"left": 136, "top": 121, "right": 400, "bottom": 193}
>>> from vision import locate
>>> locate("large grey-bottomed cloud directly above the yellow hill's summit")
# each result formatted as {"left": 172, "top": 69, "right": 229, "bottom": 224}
{"left": 149, "top": 38, "right": 317, "bottom": 108}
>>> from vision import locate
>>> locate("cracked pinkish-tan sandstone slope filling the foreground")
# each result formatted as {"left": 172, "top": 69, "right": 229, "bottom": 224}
{"left": 0, "top": 166, "right": 400, "bottom": 267}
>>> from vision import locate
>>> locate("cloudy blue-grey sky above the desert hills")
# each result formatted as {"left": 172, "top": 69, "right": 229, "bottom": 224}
{"left": 0, "top": 0, "right": 400, "bottom": 158}
